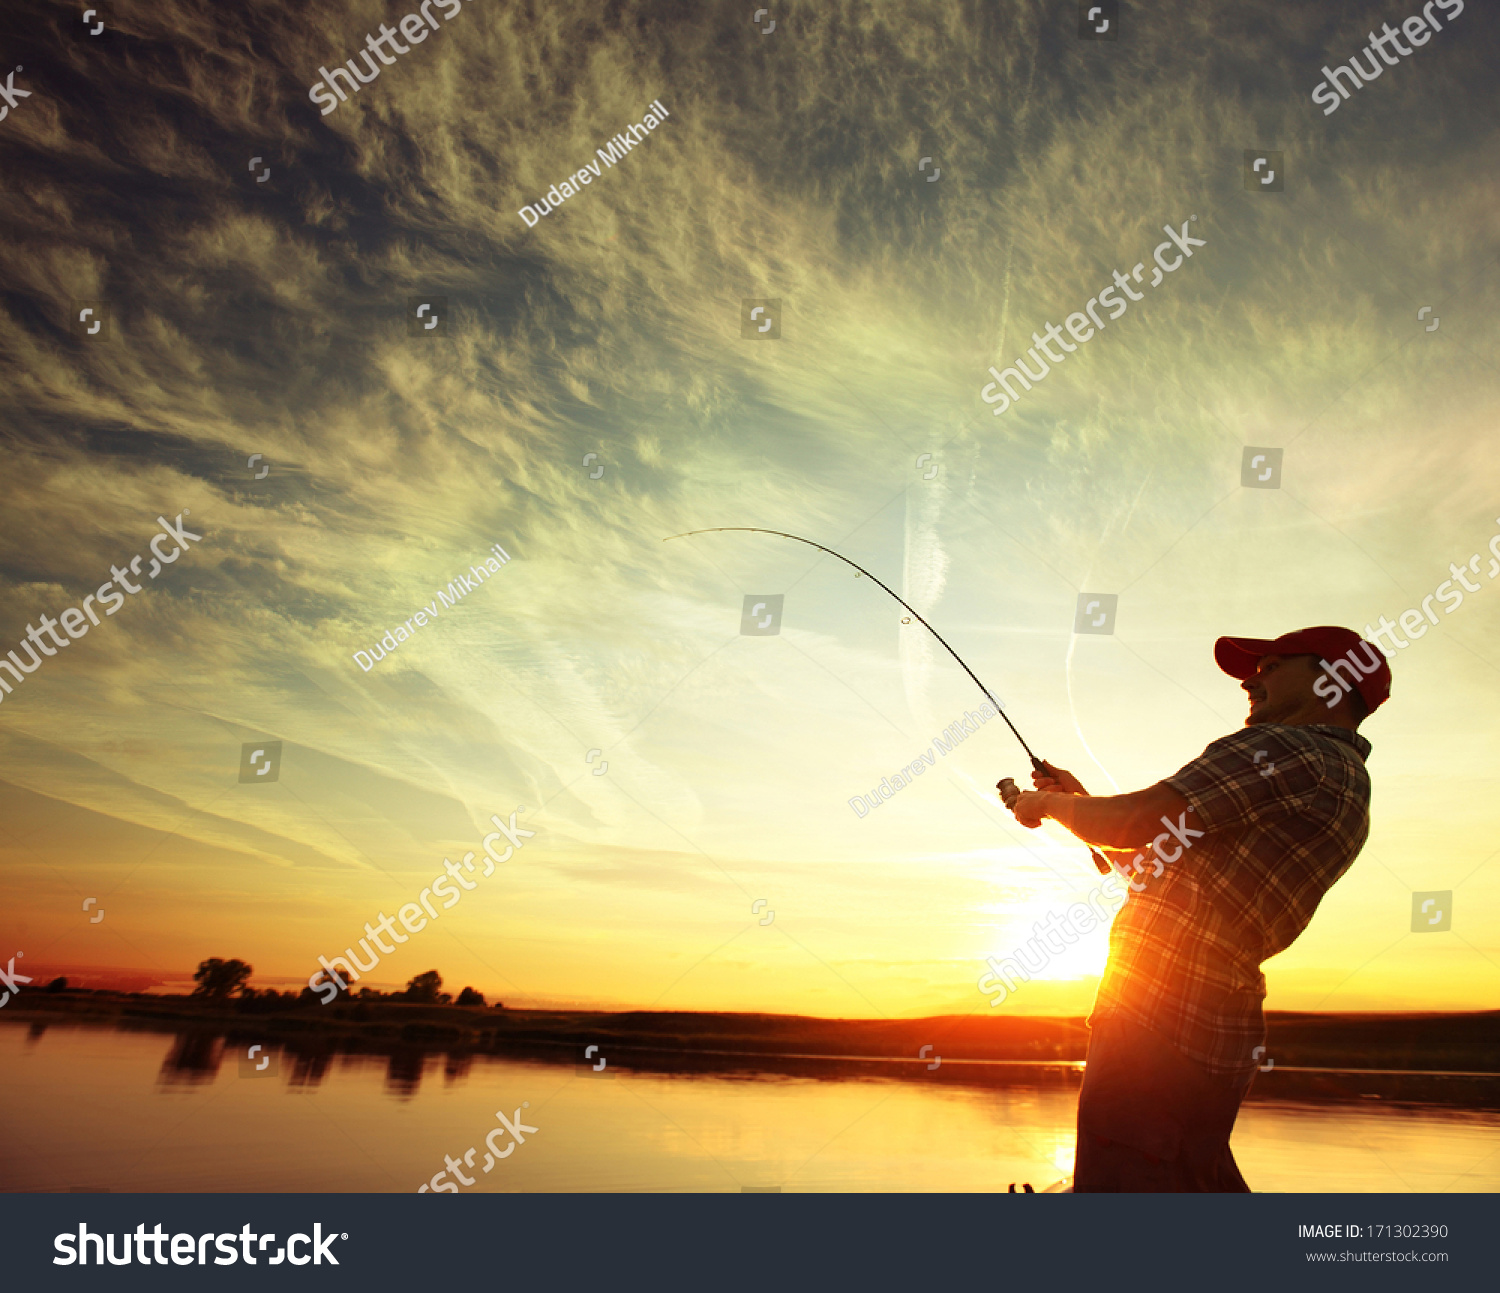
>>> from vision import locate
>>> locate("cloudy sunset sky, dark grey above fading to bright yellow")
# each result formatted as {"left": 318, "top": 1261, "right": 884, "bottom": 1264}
{"left": 0, "top": 0, "right": 1500, "bottom": 1017}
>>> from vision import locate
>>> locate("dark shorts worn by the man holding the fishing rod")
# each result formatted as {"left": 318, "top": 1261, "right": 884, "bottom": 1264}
{"left": 1073, "top": 1014, "right": 1256, "bottom": 1194}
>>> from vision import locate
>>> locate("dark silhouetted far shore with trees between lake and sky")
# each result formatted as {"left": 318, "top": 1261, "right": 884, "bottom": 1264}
{"left": 6, "top": 989, "right": 1500, "bottom": 1109}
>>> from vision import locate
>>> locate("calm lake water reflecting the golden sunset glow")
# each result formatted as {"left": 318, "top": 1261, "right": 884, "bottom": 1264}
{"left": 0, "top": 1025, "right": 1500, "bottom": 1193}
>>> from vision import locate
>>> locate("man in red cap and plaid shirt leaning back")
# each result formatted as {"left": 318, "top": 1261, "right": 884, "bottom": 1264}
{"left": 1004, "top": 627, "right": 1391, "bottom": 1194}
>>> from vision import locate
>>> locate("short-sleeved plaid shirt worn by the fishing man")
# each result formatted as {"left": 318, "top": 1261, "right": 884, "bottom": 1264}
{"left": 1089, "top": 723, "right": 1370, "bottom": 1076}
